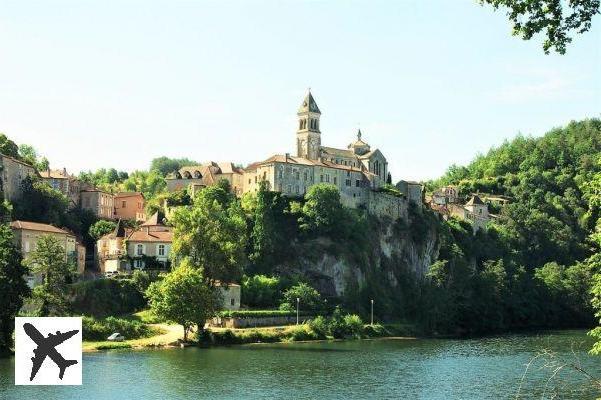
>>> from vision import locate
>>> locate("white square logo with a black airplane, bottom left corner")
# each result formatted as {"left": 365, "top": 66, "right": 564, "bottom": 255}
{"left": 15, "top": 317, "right": 82, "bottom": 385}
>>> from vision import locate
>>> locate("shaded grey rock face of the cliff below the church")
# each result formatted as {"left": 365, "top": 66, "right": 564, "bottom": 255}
{"left": 278, "top": 211, "right": 440, "bottom": 297}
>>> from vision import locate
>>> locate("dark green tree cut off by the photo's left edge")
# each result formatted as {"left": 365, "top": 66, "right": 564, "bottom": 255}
{"left": 0, "top": 224, "right": 30, "bottom": 354}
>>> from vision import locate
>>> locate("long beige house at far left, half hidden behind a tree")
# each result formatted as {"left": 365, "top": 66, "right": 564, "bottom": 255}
{"left": 10, "top": 221, "right": 86, "bottom": 288}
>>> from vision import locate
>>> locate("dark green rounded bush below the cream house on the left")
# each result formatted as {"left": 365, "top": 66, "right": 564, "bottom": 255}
{"left": 70, "top": 279, "right": 146, "bottom": 317}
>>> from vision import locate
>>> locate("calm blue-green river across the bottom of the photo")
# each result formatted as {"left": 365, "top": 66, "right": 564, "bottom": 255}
{"left": 0, "top": 331, "right": 601, "bottom": 400}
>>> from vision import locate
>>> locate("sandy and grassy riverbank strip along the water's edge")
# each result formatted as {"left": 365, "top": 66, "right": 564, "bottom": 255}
{"left": 83, "top": 324, "right": 417, "bottom": 352}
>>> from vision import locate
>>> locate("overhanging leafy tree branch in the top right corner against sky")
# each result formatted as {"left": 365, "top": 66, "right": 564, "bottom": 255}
{"left": 480, "top": 0, "right": 600, "bottom": 54}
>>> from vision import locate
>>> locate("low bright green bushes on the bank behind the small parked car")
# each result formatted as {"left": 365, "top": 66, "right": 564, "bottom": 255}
{"left": 82, "top": 317, "right": 154, "bottom": 340}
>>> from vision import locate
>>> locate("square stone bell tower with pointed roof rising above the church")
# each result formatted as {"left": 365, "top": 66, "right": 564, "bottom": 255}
{"left": 296, "top": 90, "right": 321, "bottom": 160}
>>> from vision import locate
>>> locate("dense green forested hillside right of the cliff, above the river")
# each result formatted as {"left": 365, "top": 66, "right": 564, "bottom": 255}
{"left": 422, "top": 119, "right": 601, "bottom": 333}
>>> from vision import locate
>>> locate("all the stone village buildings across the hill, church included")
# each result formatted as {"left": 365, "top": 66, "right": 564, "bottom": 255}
{"left": 0, "top": 92, "right": 490, "bottom": 292}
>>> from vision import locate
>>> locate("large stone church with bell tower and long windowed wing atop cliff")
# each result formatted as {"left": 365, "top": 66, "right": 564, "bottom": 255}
{"left": 243, "top": 92, "right": 388, "bottom": 207}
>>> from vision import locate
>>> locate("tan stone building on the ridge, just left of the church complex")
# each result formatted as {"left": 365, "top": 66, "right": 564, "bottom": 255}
{"left": 165, "top": 161, "right": 244, "bottom": 197}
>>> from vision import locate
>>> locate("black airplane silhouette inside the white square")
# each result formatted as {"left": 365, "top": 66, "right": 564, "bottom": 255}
{"left": 23, "top": 323, "right": 79, "bottom": 382}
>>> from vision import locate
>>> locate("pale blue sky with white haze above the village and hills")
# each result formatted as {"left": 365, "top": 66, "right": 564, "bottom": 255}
{"left": 0, "top": 0, "right": 601, "bottom": 180}
